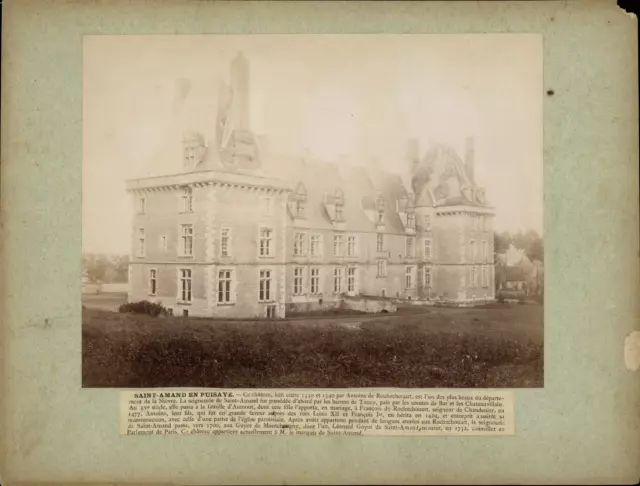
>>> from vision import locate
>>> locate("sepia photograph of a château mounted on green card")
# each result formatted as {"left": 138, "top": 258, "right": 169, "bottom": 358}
{"left": 82, "top": 34, "right": 544, "bottom": 388}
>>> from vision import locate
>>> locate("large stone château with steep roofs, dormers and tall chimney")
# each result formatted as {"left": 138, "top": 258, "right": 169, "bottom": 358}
{"left": 127, "top": 52, "right": 495, "bottom": 318}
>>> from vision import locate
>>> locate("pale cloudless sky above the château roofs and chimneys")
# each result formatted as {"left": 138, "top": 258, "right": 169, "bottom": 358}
{"left": 83, "top": 34, "right": 543, "bottom": 253}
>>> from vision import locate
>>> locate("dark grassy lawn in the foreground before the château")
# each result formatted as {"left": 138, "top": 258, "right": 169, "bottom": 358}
{"left": 83, "top": 306, "right": 543, "bottom": 388}
